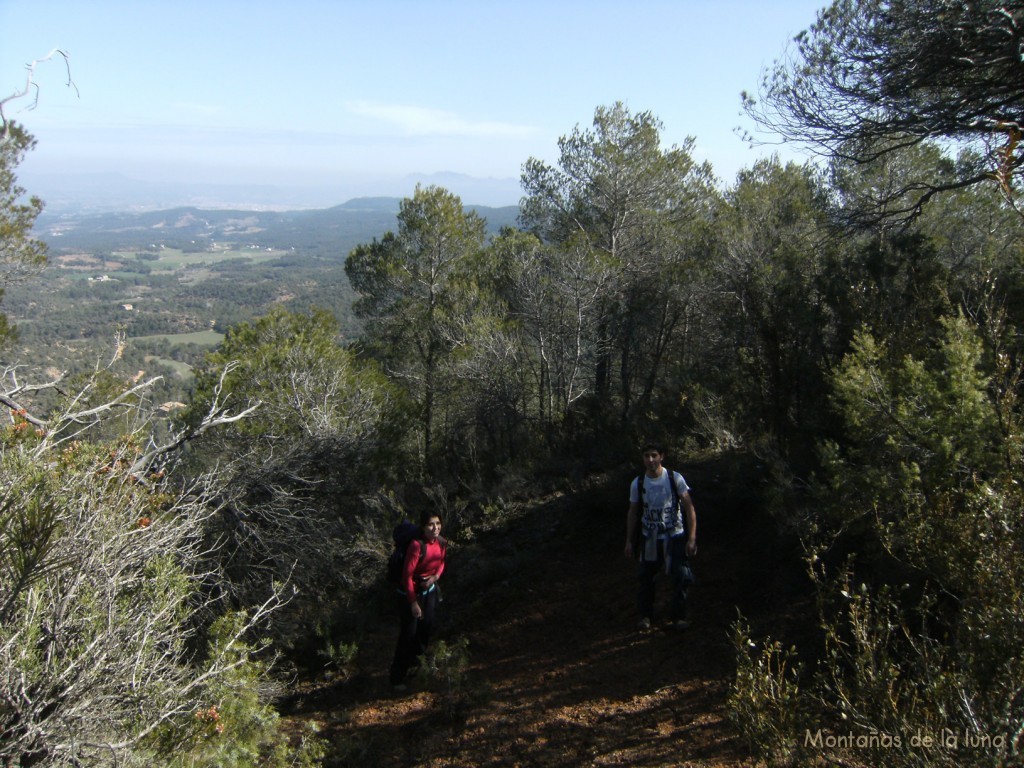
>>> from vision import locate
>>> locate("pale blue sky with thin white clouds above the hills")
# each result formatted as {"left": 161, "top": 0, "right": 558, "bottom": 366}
{"left": 0, "top": 0, "right": 824, "bottom": 203}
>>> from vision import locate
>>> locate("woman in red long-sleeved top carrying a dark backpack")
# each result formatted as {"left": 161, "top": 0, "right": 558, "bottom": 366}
{"left": 391, "top": 513, "right": 446, "bottom": 690}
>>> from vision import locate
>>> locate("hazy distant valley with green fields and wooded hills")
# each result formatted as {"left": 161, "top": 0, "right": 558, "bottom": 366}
{"left": 4, "top": 198, "right": 517, "bottom": 401}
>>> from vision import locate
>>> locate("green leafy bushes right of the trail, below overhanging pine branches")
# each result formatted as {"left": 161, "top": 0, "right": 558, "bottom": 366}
{"left": 731, "top": 316, "right": 1024, "bottom": 768}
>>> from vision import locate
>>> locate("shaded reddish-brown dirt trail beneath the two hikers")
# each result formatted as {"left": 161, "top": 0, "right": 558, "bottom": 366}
{"left": 289, "top": 460, "right": 785, "bottom": 768}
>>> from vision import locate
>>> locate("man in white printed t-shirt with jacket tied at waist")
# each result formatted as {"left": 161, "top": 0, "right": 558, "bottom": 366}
{"left": 626, "top": 443, "right": 697, "bottom": 629}
